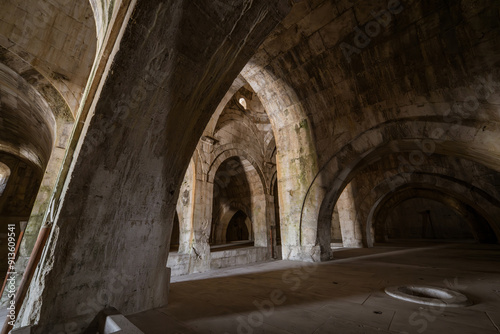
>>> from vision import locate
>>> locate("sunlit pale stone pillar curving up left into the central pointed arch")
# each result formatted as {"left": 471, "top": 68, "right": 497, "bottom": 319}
{"left": 242, "top": 66, "right": 324, "bottom": 261}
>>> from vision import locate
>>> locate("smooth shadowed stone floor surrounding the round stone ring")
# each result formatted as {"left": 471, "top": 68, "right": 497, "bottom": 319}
{"left": 128, "top": 244, "right": 500, "bottom": 334}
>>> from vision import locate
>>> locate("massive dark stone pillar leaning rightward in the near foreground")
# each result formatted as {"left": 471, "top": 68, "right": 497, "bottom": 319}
{"left": 21, "top": 0, "right": 290, "bottom": 333}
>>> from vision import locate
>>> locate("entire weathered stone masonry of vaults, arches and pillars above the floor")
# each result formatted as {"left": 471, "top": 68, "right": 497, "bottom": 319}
{"left": 0, "top": 0, "right": 500, "bottom": 333}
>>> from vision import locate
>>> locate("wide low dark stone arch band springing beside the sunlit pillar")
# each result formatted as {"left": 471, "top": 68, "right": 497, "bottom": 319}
{"left": 316, "top": 117, "right": 500, "bottom": 260}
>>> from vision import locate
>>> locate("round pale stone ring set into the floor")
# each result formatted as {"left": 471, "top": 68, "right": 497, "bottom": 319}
{"left": 385, "top": 285, "right": 471, "bottom": 307}
